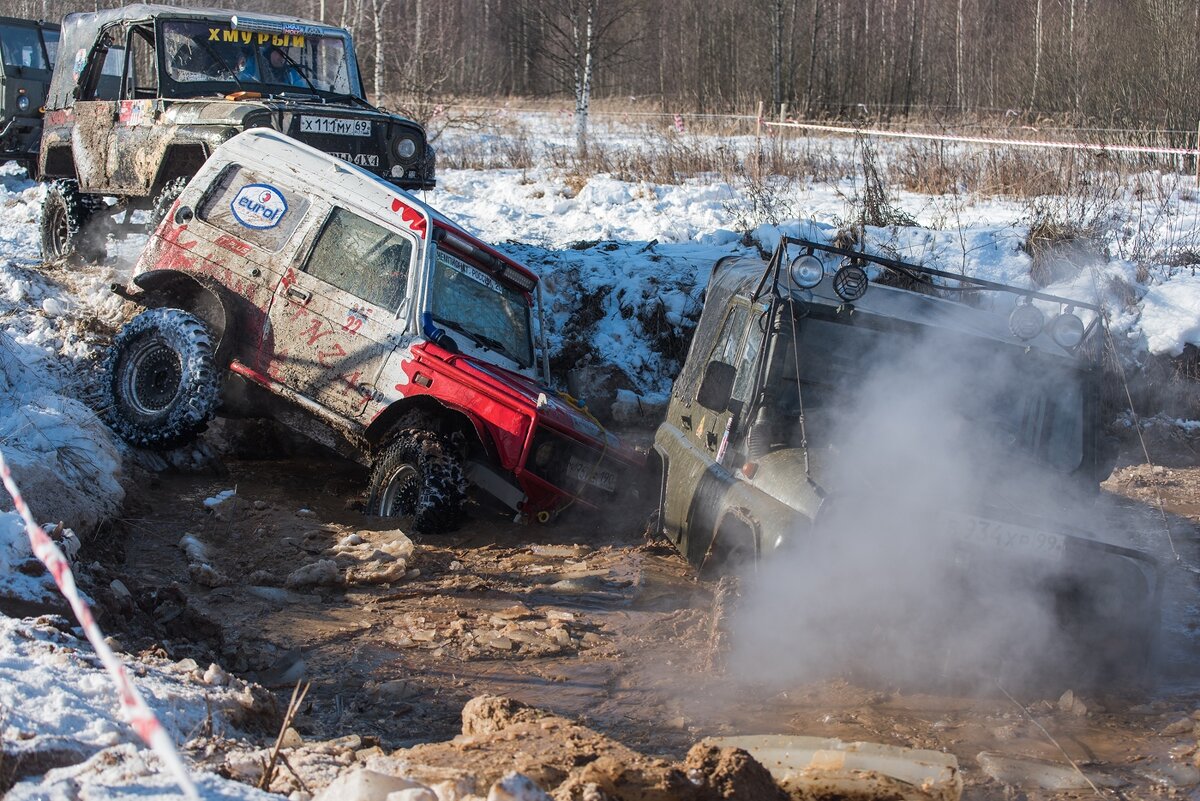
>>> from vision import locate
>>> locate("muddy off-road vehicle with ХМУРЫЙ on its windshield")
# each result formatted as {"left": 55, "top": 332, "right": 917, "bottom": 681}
{"left": 41, "top": 5, "right": 434, "bottom": 260}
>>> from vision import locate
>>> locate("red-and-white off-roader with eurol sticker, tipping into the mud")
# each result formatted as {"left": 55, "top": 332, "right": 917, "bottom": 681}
{"left": 103, "top": 130, "right": 642, "bottom": 531}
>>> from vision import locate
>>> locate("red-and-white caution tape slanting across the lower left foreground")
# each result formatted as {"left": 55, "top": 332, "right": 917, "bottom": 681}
{"left": 0, "top": 451, "right": 200, "bottom": 801}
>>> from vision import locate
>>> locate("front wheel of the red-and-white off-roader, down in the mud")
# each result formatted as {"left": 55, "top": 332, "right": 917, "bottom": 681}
{"left": 367, "top": 428, "right": 467, "bottom": 534}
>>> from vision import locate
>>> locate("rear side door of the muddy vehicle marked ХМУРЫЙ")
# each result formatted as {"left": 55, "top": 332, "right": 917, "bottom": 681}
{"left": 71, "top": 25, "right": 125, "bottom": 193}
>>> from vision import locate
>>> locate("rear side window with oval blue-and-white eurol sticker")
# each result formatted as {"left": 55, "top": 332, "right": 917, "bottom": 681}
{"left": 199, "top": 164, "right": 310, "bottom": 252}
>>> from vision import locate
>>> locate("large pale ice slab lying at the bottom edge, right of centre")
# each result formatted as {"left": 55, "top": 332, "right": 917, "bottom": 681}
{"left": 704, "top": 734, "right": 962, "bottom": 801}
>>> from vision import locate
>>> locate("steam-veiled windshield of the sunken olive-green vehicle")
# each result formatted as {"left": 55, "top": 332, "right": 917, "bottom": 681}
{"left": 775, "top": 317, "right": 1085, "bottom": 472}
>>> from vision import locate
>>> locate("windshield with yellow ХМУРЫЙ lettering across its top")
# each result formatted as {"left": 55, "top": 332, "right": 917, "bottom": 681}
{"left": 162, "top": 19, "right": 362, "bottom": 97}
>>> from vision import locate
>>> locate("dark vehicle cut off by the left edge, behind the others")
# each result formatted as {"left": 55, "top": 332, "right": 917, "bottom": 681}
{"left": 0, "top": 17, "right": 59, "bottom": 175}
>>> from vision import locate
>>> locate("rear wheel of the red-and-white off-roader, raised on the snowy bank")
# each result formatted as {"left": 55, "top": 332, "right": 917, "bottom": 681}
{"left": 102, "top": 308, "right": 221, "bottom": 450}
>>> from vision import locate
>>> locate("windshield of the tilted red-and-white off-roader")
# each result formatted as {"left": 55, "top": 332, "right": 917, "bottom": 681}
{"left": 430, "top": 251, "right": 533, "bottom": 367}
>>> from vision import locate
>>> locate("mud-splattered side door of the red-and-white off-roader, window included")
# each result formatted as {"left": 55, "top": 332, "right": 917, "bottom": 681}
{"left": 270, "top": 206, "right": 416, "bottom": 417}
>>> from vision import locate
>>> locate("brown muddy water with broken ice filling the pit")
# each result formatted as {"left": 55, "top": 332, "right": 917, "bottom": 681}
{"left": 96, "top": 450, "right": 1200, "bottom": 797}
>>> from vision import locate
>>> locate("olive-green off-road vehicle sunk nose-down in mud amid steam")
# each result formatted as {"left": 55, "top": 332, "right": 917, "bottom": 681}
{"left": 654, "top": 237, "right": 1160, "bottom": 677}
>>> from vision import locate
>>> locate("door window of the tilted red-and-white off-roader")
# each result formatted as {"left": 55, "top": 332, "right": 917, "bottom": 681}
{"left": 304, "top": 207, "right": 413, "bottom": 312}
